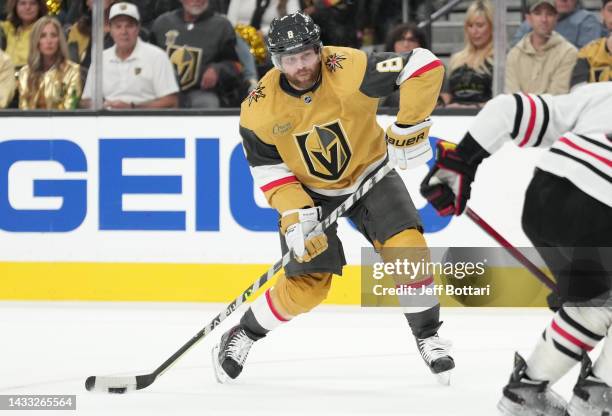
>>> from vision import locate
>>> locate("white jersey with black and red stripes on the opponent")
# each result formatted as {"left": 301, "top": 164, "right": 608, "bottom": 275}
{"left": 469, "top": 82, "right": 612, "bottom": 207}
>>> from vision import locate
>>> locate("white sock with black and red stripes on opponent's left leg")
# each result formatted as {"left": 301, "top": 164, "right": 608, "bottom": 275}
{"left": 527, "top": 306, "right": 609, "bottom": 384}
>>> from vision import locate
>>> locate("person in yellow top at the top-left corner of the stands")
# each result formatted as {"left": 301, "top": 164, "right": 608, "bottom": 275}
{"left": 0, "top": 0, "right": 47, "bottom": 69}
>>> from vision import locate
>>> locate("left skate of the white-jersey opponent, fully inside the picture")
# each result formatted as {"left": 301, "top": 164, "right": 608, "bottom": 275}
{"left": 497, "top": 353, "right": 566, "bottom": 416}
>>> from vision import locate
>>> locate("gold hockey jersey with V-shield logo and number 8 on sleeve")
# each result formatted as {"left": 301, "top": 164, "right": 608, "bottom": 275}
{"left": 240, "top": 46, "right": 444, "bottom": 213}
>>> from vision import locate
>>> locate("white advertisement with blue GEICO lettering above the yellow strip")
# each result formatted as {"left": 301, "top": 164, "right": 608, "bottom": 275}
{"left": 0, "top": 116, "right": 538, "bottom": 264}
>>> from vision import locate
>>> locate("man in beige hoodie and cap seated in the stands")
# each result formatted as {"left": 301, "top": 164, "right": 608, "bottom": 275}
{"left": 505, "top": 0, "right": 578, "bottom": 95}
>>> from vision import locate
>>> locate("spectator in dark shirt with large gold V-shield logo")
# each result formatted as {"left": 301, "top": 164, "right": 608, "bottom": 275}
{"left": 152, "top": 0, "right": 248, "bottom": 108}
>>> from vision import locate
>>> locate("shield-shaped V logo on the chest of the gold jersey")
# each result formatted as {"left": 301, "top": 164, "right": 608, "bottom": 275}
{"left": 295, "top": 120, "right": 351, "bottom": 181}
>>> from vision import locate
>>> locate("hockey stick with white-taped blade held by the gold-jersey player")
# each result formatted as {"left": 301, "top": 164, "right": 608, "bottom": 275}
{"left": 85, "top": 164, "right": 393, "bottom": 393}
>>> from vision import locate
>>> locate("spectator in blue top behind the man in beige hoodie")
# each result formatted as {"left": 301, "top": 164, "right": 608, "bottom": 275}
{"left": 512, "top": 0, "right": 603, "bottom": 49}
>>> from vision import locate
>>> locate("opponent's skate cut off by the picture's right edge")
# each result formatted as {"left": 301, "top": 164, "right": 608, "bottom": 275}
{"left": 566, "top": 353, "right": 612, "bottom": 416}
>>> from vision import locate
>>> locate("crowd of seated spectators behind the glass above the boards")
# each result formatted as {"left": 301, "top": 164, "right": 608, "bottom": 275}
{"left": 0, "top": 0, "right": 612, "bottom": 110}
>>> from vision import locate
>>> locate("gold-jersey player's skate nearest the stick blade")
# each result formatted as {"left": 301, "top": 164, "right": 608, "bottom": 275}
{"left": 212, "top": 325, "right": 255, "bottom": 383}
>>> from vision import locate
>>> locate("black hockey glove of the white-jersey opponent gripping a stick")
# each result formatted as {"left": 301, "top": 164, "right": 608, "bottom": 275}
{"left": 421, "top": 133, "right": 489, "bottom": 216}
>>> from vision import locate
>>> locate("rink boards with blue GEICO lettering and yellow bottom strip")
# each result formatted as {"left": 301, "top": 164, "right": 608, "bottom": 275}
{"left": 0, "top": 116, "right": 543, "bottom": 304}
